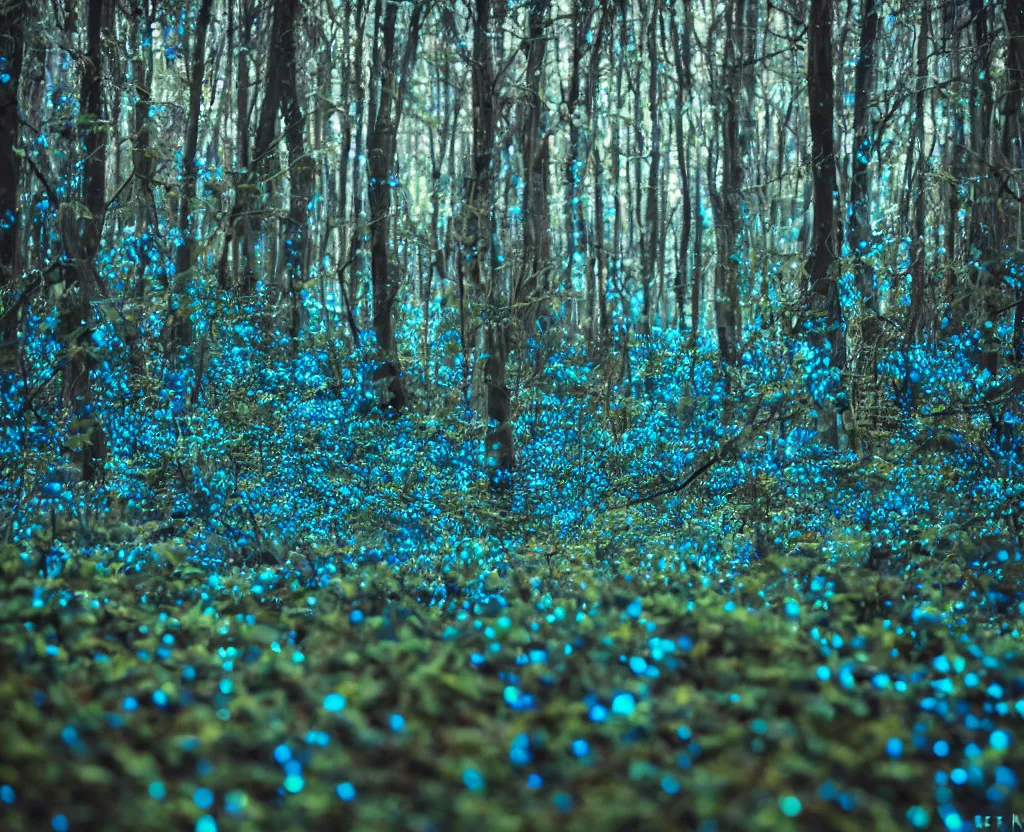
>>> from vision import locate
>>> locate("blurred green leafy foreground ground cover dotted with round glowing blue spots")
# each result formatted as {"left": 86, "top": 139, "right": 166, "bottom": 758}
{"left": 0, "top": 497, "right": 1024, "bottom": 832}
